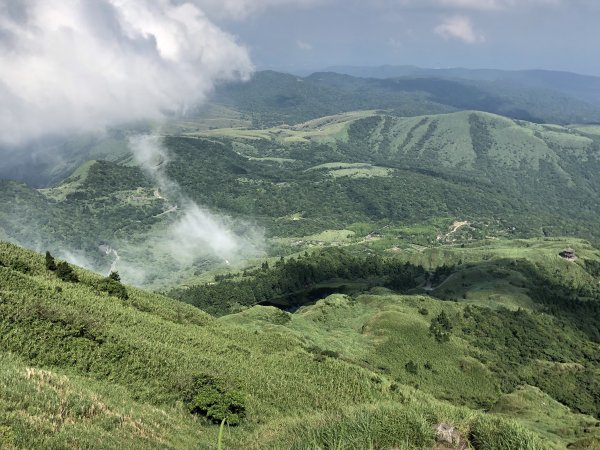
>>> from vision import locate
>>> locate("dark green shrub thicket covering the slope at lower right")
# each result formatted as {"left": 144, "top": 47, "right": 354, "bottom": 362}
{"left": 463, "top": 307, "right": 600, "bottom": 417}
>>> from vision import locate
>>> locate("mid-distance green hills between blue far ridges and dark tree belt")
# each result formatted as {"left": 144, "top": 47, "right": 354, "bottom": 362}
{"left": 0, "top": 110, "right": 600, "bottom": 288}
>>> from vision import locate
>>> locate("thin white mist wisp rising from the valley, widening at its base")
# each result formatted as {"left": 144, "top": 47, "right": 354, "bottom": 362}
{"left": 106, "top": 134, "right": 265, "bottom": 286}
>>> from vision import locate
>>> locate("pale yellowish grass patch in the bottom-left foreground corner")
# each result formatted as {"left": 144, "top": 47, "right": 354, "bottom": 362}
{"left": 0, "top": 353, "right": 206, "bottom": 450}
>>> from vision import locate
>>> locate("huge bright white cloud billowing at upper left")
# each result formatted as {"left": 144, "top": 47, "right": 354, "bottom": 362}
{"left": 0, "top": 0, "right": 252, "bottom": 145}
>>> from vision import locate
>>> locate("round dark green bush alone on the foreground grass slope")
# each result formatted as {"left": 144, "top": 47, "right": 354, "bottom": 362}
{"left": 184, "top": 375, "right": 246, "bottom": 425}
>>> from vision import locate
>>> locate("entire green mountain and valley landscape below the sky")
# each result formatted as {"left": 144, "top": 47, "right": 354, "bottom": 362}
{"left": 0, "top": 68, "right": 600, "bottom": 450}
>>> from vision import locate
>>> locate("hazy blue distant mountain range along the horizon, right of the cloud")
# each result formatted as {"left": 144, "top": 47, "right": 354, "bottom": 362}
{"left": 215, "top": 71, "right": 600, "bottom": 128}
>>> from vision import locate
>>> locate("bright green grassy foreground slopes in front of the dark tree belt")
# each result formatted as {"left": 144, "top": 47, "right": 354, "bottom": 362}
{"left": 0, "top": 244, "right": 597, "bottom": 449}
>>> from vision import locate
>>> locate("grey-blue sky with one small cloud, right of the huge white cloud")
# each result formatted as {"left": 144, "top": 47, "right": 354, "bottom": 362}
{"left": 218, "top": 0, "right": 600, "bottom": 75}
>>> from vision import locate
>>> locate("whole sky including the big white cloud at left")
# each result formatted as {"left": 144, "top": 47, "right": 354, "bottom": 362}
{"left": 0, "top": 0, "right": 600, "bottom": 149}
